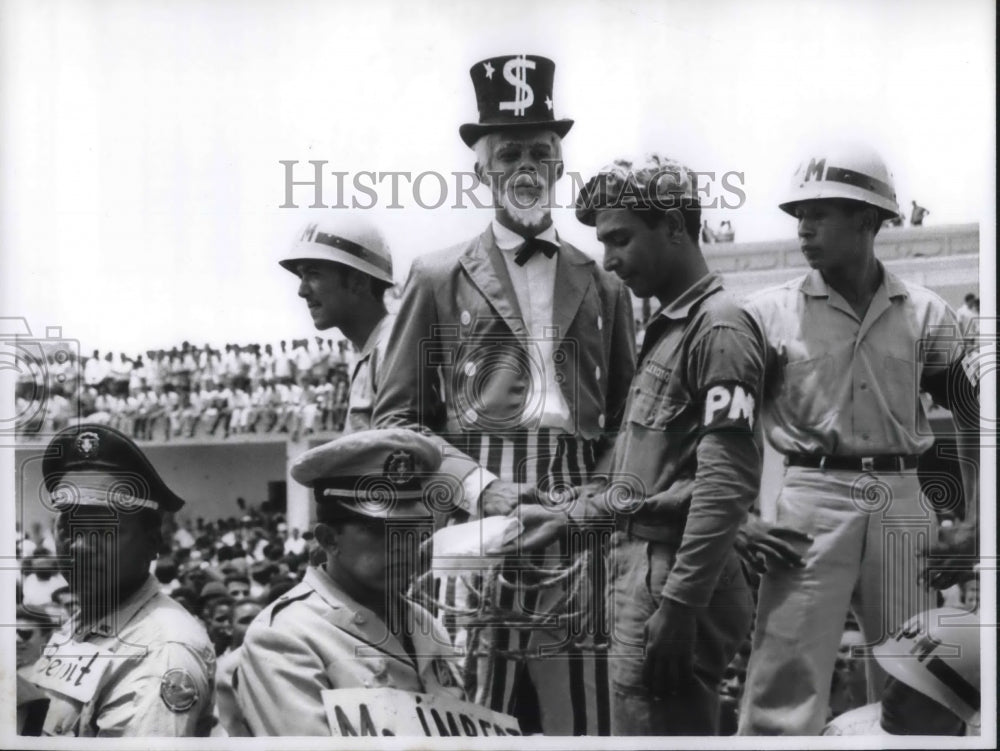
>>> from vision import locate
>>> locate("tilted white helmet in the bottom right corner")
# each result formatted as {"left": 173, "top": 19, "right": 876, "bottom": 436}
{"left": 873, "top": 608, "right": 980, "bottom": 726}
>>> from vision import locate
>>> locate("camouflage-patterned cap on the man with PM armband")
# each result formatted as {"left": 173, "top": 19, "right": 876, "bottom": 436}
{"left": 576, "top": 153, "right": 698, "bottom": 227}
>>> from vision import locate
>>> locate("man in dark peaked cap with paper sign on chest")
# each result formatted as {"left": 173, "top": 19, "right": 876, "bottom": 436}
{"left": 26, "top": 425, "right": 215, "bottom": 737}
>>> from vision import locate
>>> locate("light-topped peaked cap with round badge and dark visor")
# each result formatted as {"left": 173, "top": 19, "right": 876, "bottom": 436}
{"left": 291, "top": 428, "right": 441, "bottom": 519}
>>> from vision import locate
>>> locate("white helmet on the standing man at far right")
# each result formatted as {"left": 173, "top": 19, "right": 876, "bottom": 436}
{"left": 778, "top": 144, "right": 899, "bottom": 219}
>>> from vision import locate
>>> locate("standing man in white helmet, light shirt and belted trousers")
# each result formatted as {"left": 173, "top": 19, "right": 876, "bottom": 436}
{"left": 739, "top": 145, "right": 979, "bottom": 735}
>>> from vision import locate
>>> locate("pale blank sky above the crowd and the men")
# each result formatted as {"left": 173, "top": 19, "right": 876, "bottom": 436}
{"left": 0, "top": 0, "right": 996, "bottom": 354}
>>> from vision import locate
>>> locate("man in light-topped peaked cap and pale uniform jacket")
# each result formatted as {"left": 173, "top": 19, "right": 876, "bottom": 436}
{"left": 233, "top": 429, "right": 465, "bottom": 736}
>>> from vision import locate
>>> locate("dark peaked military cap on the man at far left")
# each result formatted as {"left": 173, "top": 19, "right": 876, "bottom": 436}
{"left": 42, "top": 424, "right": 184, "bottom": 511}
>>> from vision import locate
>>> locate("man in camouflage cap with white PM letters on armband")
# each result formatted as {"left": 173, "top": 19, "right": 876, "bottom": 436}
{"left": 577, "top": 154, "right": 763, "bottom": 735}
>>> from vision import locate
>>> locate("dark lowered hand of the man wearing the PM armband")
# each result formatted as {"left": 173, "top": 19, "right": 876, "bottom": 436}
{"left": 642, "top": 597, "right": 695, "bottom": 697}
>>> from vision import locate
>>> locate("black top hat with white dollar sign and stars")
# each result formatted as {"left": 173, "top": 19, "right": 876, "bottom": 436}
{"left": 458, "top": 55, "right": 573, "bottom": 148}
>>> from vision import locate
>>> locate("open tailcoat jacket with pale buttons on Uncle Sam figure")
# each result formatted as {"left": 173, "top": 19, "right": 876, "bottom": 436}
{"left": 374, "top": 228, "right": 635, "bottom": 506}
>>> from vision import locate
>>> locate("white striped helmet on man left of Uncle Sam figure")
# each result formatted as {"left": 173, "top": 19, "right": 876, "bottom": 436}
{"left": 278, "top": 213, "right": 392, "bottom": 284}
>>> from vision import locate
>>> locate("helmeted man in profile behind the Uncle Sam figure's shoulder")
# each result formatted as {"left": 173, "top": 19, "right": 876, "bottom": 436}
{"left": 279, "top": 213, "right": 393, "bottom": 432}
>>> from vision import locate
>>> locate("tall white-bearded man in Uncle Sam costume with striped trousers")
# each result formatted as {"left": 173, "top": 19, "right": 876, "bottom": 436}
{"left": 375, "top": 55, "right": 635, "bottom": 735}
